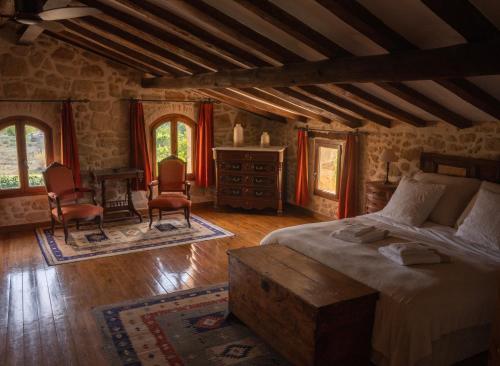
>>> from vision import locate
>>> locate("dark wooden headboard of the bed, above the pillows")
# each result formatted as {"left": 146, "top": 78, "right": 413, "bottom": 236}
{"left": 420, "top": 153, "right": 500, "bottom": 183}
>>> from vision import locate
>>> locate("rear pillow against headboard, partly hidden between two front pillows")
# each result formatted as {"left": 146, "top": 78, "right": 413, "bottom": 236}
{"left": 413, "top": 172, "right": 481, "bottom": 227}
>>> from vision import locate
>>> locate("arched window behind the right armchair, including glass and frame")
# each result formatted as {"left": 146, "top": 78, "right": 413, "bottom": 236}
{"left": 151, "top": 114, "right": 196, "bottom": 179}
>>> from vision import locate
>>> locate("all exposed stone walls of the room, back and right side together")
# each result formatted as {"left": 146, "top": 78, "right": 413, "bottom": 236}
{"left": 0, "top": 27, "right": 500, "bottom": 226}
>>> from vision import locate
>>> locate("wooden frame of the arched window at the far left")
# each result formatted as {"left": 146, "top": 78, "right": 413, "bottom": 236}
{"left": 0, "top": 116, "right": 54, "bottom": 198}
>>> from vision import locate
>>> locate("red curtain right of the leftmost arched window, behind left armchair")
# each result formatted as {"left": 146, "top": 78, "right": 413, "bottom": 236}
{"left": 61, "top": 100, "right": 81, "bottom": 187}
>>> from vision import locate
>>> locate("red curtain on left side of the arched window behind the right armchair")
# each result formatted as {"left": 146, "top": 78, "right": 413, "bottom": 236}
{"left": 130, "top": 100, "right": 152, "bottom": 191}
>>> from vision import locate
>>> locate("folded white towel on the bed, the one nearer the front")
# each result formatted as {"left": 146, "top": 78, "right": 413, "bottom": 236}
{"left": 378, "top": 242, "right": 450, "bottom": 266}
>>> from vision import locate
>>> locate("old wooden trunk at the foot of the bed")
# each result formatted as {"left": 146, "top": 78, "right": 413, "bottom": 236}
{"left": 229, "top": 245, "right": 378, "bottom": 366}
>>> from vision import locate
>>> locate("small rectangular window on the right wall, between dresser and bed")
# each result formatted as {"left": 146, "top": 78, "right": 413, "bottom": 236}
{"left": 314, "top": 140, "right": 342, "bottom": 199}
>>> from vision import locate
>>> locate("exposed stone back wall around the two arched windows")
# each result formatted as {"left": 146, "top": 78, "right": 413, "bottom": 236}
{"left": 0, "top": 27, "right": 279, "bottom": 226}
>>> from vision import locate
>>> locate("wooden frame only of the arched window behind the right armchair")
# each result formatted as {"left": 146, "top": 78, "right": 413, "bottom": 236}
{"left": 150, "top": 114, "right": 196, "bottom": 180}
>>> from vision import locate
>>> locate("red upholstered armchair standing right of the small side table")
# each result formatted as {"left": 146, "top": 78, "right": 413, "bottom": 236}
{"left": 148, "top": 155, "right": 191, "bottom": 228}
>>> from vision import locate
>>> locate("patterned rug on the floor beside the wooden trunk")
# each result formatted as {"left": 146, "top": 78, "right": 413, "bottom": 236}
{"left": 93, "top": 284, "right": 288, "bottom": 366}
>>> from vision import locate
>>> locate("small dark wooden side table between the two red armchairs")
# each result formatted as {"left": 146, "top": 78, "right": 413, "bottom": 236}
{"left": 92, "top": 168, "right": 144, "bottom": 222}
